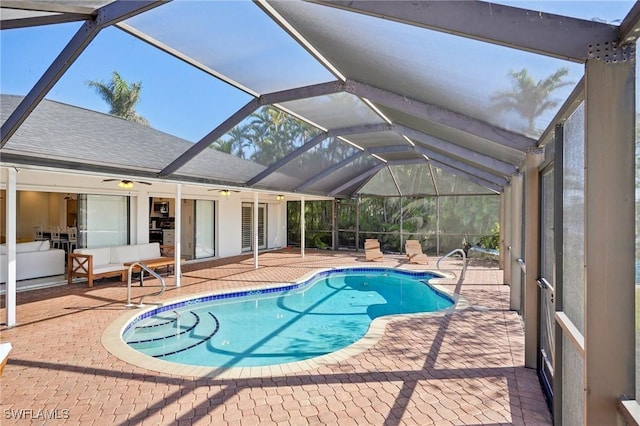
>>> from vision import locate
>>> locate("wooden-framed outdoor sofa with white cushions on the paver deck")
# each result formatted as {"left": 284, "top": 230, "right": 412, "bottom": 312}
{"left": 67, "top": 243, "right": 174, "bottom": 287}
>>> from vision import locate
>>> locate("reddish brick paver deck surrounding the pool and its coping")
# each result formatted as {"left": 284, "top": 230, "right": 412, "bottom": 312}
{"left": 0, "top": 250, "right": 552, "bottom": 426}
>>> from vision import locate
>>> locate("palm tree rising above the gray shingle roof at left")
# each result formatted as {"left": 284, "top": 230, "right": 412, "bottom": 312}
{"left": 87, "top": 71, "right": 149, "bottom": 126}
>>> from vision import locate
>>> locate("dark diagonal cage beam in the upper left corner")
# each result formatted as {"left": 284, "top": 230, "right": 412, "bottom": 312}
{"left": 0, "top": 0, "right": 167, "bottom": 149}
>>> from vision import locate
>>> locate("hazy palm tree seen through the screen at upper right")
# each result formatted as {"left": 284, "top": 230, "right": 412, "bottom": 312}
{"left": 491, "top": 67, "right": 573, "bottom": 136}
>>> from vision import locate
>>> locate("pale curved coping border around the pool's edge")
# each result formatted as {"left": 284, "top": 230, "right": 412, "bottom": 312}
{"left": 101, "top": 266, "right": 469, "bottom": 379}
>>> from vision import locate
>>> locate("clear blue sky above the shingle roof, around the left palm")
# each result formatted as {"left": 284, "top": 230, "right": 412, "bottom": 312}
{"left": 0, "top": 23, "right": 251, "bottom": 141}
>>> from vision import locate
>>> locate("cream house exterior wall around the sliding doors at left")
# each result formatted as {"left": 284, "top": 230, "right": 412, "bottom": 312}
{"left": 0, "top": 167, "right": 324, "bottom": 258}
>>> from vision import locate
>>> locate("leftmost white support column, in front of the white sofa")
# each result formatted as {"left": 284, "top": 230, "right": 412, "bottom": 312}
{"left": 2, "top": 168, "right": 18, "bottom": 327}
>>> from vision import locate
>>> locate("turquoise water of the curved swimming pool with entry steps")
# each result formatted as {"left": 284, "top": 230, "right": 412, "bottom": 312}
{"left": 123, "top": 268, "right": 454, "bottom": 367}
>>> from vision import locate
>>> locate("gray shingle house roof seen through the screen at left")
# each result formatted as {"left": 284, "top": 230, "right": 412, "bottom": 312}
{"left": 0, "top": 95, "right": 265, "bottom": 184}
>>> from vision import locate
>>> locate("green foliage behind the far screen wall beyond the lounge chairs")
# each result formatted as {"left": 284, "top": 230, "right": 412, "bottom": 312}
{"left": 287, "top": 195, "right": 500, "bottom": 253}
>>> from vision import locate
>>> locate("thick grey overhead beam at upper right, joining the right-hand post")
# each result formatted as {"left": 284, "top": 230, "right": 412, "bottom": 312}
{"left": 312, "top": 0, "right": 618, "bottom": 63}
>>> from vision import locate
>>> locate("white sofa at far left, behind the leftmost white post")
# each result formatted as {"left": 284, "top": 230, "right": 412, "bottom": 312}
{"left": 0, "top": 240, "right": 65, "bottom": 283}
